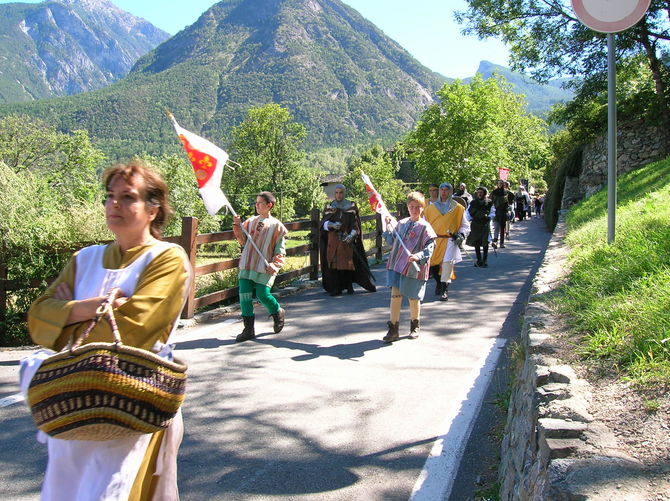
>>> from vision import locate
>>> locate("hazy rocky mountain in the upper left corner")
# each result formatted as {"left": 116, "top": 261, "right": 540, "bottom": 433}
{"left": 0, "top": 0, "right": 170, "bottom": 102}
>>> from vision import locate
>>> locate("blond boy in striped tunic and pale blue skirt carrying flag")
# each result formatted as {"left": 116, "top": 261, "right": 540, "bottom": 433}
{"left": 383, "top": 191, "right": 437, "bottom": 343}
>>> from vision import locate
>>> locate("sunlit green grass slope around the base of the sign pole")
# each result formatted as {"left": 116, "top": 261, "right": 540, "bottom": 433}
{"left": 552, "top": 158, "right": 670, "bottom": 387}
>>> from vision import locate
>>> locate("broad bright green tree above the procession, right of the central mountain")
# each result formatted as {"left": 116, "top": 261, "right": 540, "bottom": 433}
{"left": 406, "top": 75, "right": 549, "bottom": 186}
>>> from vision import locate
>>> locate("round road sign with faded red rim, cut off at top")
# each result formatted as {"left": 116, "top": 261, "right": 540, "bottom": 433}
{"left": 572, "top": 0, "right": 651, "bottom": 33}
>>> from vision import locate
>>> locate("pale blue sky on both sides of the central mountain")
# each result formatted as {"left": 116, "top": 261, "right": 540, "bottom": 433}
{"left": 0, "top": 0, "right": 508, "bottom": 78}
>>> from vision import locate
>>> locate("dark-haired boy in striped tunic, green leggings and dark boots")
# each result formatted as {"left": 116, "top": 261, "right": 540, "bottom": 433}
{"left": 233, "top": 191, "right": 288, "bottom": 342}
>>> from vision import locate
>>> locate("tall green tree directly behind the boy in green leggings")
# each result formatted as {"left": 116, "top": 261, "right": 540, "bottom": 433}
{"left": 223, "top": 104, "right": 320, "bottom": 220}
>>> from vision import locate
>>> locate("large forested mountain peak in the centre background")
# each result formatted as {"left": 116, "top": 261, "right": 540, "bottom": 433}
{"left": 129, "top": 0, "right": 444, "bottom": 144}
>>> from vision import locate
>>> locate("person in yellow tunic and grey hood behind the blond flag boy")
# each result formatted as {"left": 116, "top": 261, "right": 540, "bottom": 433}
{"left": 425, "top": 183, "right": 470, "bottom": 301}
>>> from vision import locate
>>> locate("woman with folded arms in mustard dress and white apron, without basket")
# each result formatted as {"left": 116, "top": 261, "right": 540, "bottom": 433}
{"left": 28, "top": 162, "right": 192, "bottom": 501}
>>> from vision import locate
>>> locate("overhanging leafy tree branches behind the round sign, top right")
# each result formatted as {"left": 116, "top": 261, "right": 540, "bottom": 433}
{"left": 456, "top": 0, "right": 670, "bottom": 129}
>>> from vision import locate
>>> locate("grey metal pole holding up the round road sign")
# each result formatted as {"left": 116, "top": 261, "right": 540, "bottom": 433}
{"left": 607, "top": 33, "right": 617, "bottom": 244}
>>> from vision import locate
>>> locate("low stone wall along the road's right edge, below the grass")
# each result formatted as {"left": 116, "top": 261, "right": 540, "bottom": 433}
{"left": 499, "top": 216, "right": 641, "bottom": 501}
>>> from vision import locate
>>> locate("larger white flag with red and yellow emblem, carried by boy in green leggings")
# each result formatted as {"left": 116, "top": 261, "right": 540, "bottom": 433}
{"left": 166, "top": 111, "right": 232, "bottom": 216}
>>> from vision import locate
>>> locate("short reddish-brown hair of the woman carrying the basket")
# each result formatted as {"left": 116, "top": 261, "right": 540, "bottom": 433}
{"left": 102, "top": 160, "right": 174, "bottom": 239}
